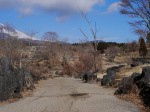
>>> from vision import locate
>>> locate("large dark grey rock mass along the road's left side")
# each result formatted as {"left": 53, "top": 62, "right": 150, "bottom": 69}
{"left": 0, "top": 57, "right": 33, "bottom": 101}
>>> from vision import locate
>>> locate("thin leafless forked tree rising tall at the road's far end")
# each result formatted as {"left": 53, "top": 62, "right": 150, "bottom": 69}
{"left": 80, "top": 12, "right": 98, "bottom": 72}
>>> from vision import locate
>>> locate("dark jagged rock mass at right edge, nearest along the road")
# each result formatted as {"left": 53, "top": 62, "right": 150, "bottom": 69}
{"left": 115, "top": 67, "right": 150, "bottom": 107}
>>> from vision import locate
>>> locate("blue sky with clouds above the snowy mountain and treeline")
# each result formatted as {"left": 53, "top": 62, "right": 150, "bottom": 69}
{"left": 0, "top": 0, "right": 138, "bottom": 42}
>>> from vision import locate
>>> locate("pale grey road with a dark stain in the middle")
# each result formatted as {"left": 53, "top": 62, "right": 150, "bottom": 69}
{"left": 0, "top": 78, "right": 138, "bottom": 112}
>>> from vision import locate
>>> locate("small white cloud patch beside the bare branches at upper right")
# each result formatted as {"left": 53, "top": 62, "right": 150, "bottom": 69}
{"left": 107, "top": 2, "right": 120, "bottom": 13}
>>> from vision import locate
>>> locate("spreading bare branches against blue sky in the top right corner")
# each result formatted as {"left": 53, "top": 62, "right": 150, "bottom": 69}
{"left": 121, "top": 0, "right": 150, "bottom": 37}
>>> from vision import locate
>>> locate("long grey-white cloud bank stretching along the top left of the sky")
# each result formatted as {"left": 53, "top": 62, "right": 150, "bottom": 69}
{"left": 0, "top": 0, "right": 105, "bottom": 19}
